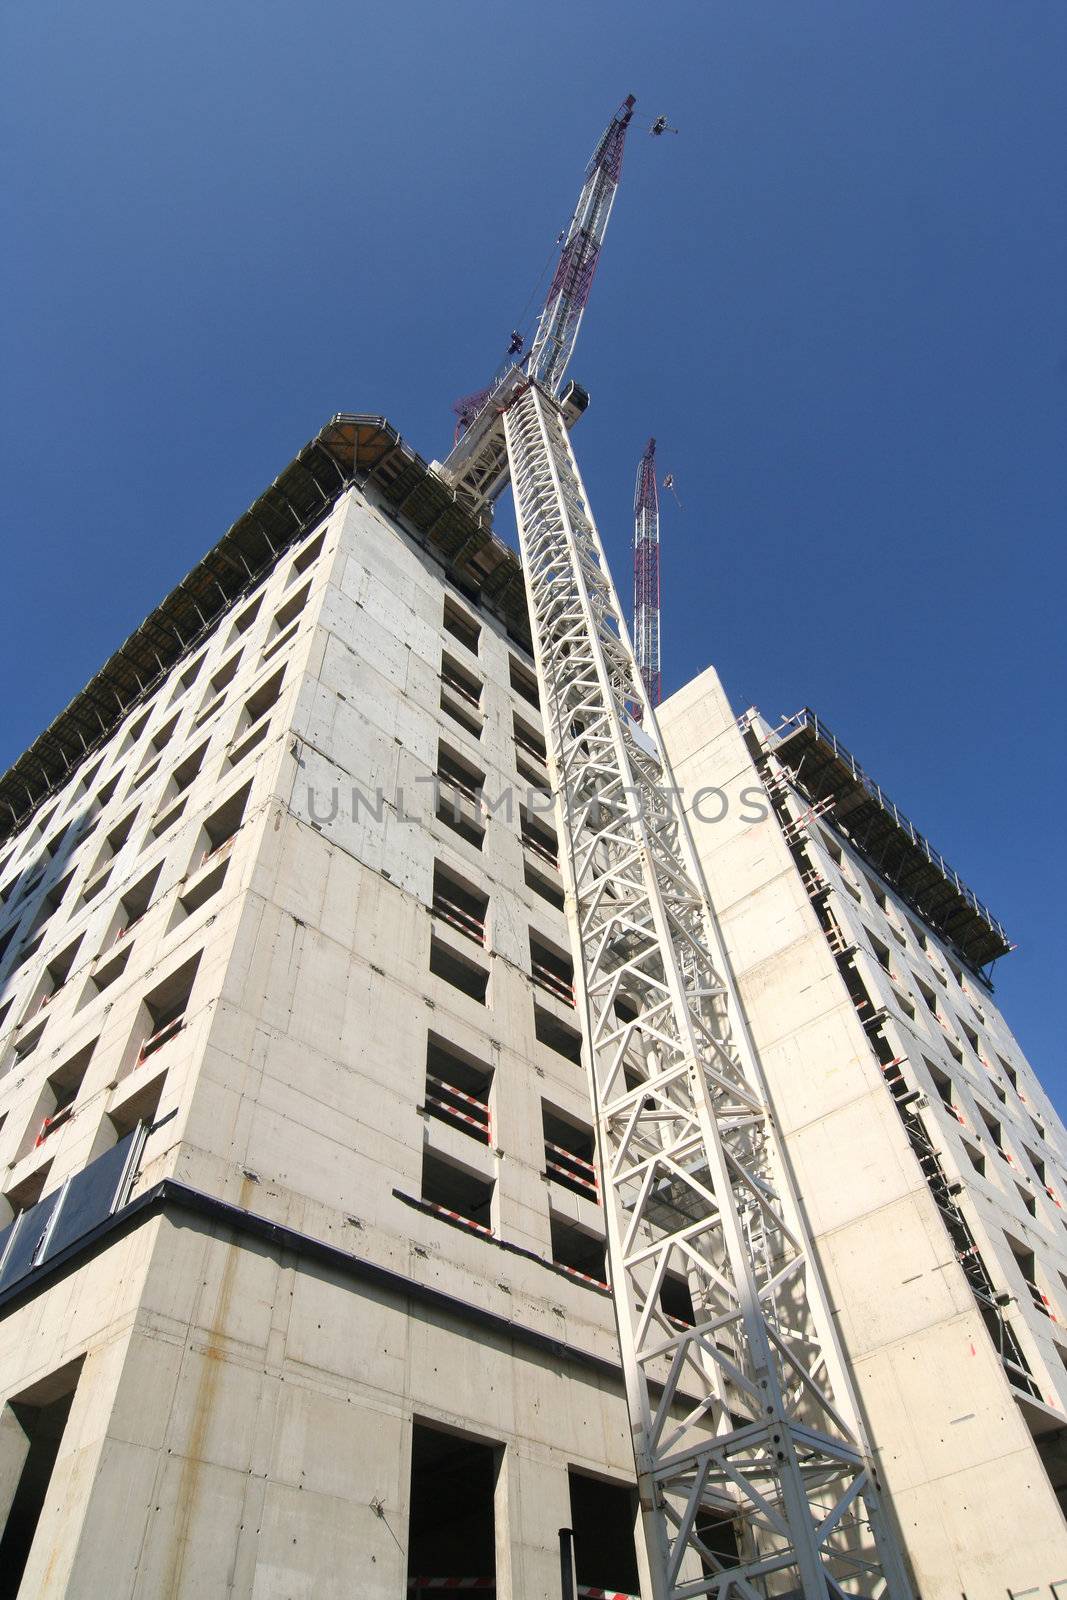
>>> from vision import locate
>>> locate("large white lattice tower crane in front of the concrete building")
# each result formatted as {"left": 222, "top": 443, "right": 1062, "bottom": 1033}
{"left": 438, "top": 98, "right": 910, "bottom": 1600}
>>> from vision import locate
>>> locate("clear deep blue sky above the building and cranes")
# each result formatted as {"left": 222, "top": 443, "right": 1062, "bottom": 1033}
{"left": 0, "top": 0, "right": 1067, "bottom": 1104}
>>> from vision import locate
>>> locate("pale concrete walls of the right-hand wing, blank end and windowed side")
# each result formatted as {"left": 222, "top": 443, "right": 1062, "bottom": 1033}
{"left": 661, "top": 670, "right": 1067, "bottom": 1600}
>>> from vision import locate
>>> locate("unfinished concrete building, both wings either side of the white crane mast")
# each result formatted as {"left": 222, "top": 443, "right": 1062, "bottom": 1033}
{"left": 0, "top": 418, "right": 1067, "bottom": 1600}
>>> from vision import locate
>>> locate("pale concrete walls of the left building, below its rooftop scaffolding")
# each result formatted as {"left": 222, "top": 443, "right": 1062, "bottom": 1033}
{"left": 0, "top": 488, "right": 652, "bottom": 1600}
